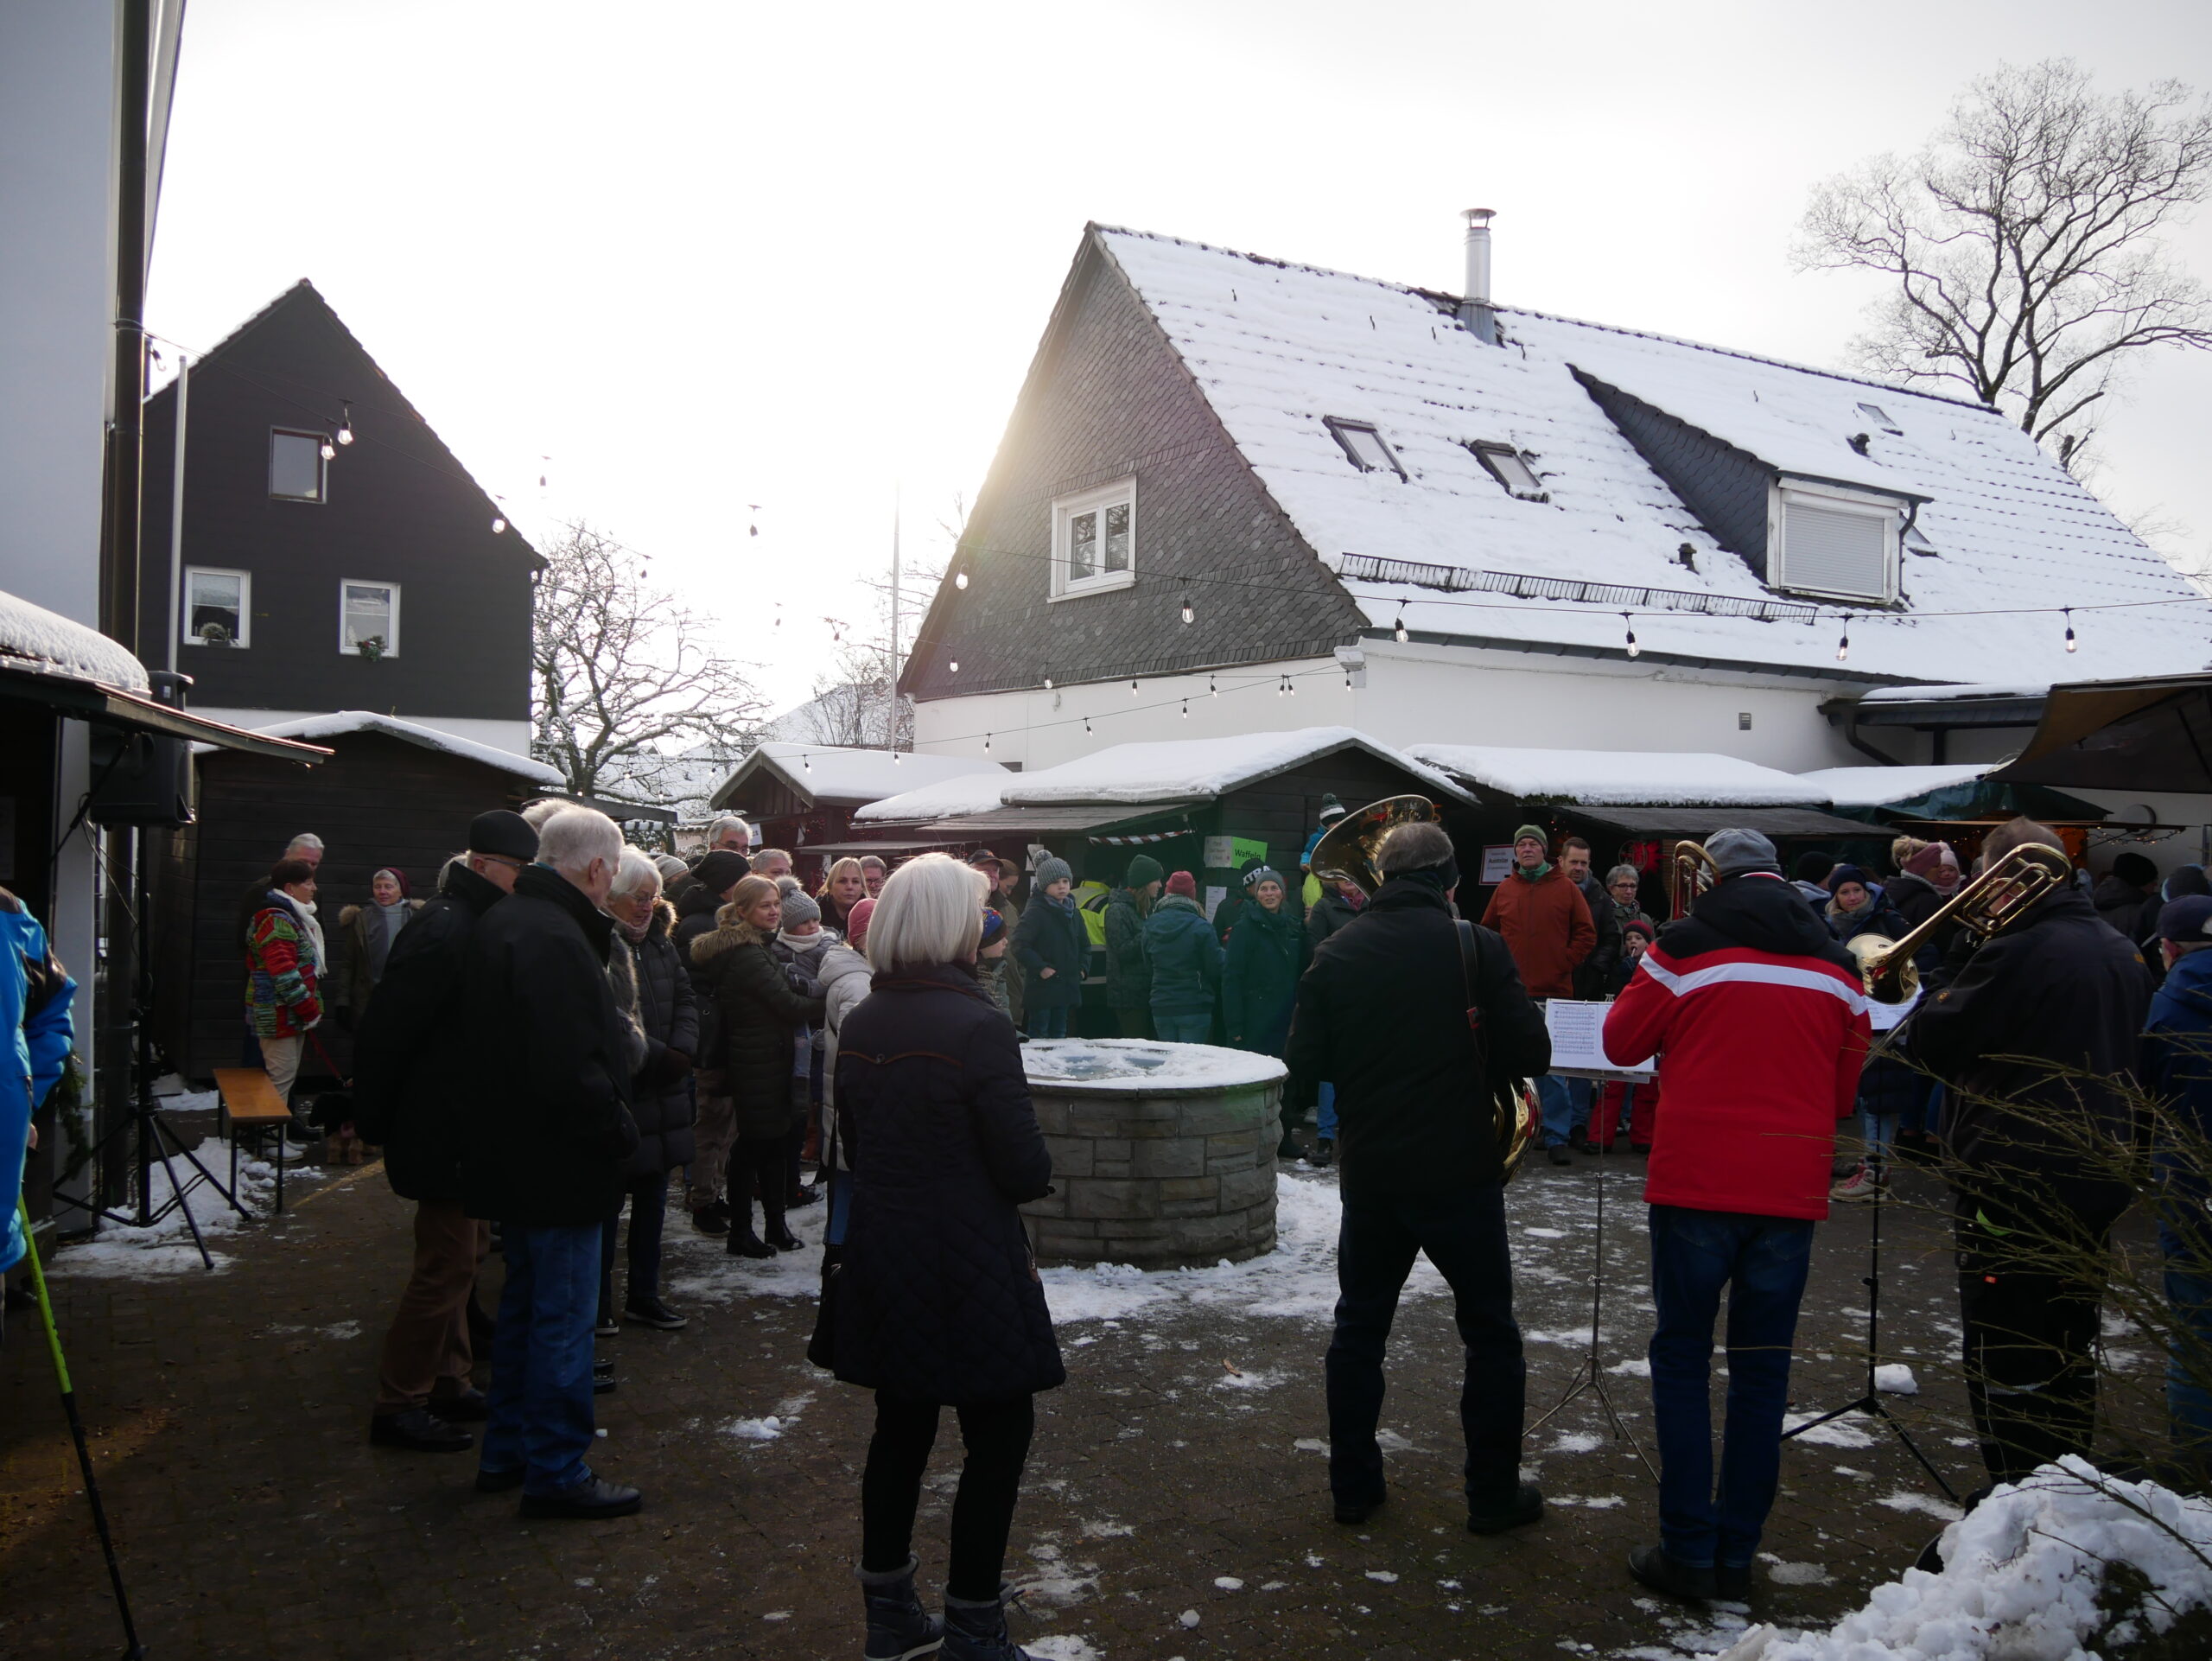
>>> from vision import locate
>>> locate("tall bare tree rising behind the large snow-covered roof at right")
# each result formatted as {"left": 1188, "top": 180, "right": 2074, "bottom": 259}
{"left": 1796, "top": 60, "right": 2212, "bottom": 469}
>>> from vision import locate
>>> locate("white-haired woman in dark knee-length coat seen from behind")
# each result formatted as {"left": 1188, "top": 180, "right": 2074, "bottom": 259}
{"left": 831, "top": 854, "right": 1066, "bottom": 1661}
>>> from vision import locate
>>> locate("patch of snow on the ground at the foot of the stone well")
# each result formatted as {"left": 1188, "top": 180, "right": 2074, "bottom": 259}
{"left": 1044, "top": 1172, "right": 1433, "bottom": 1342}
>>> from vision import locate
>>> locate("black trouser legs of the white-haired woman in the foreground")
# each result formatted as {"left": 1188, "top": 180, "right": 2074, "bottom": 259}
{"left": 861, "top": 1391, "right": 1038, "bottom": 1603}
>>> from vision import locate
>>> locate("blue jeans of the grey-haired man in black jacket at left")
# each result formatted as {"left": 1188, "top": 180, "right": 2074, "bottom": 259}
{"left": 480, "top": 1223, "right": 600, "bottom": 1495}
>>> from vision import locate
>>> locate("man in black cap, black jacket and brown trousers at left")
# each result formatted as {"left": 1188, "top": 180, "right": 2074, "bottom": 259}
{"left": 354, "top": 807, "right": 537, "bottom": 1453}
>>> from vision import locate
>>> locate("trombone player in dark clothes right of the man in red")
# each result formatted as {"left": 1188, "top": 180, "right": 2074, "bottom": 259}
{"left": 1907, "top": 818, "right": 2152, "bottom": 1482}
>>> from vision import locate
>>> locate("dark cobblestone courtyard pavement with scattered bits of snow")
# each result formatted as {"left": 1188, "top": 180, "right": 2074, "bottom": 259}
{"left": 0, "top": 1159, "right": 2008, "bottom": 1661}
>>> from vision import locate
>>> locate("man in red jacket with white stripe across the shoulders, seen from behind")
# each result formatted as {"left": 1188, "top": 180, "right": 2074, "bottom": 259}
{"left": 1606, "top": 830, "right": 1869, "bottom": 1599}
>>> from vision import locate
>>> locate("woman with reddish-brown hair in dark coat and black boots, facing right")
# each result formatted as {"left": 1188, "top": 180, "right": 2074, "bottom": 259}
{"left": 692, "top": 875, "right": 823, "bottom": 1257}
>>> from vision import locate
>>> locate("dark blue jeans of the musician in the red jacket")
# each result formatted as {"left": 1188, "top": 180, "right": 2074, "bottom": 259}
{"left": 1650, "top": 1206, "right": 1812, "bottom": 1569}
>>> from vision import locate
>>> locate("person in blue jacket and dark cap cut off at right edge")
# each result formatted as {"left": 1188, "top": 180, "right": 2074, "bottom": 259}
{"left": 2144, "top": 894, "right": 2212, "bottom": 1467}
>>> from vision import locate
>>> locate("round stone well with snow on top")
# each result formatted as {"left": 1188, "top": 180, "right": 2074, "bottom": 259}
{"left": 1022, "top": 1037, "right": 1285, "bottom": 1270}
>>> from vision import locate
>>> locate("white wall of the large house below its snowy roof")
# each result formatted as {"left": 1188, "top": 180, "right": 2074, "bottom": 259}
{"left": 916, "top": 641, "right": 1865, "bottom": 772}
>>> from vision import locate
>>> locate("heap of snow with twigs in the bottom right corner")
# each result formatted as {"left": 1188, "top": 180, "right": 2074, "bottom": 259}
{"left": 1723, "top": 1458, "right": 2212, "bottom": 1661}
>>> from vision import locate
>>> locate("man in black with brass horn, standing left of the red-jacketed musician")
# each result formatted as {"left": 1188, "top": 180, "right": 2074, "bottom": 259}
{"left": 1287, "top": 825, "right": 1551, "bottom": 1533}
